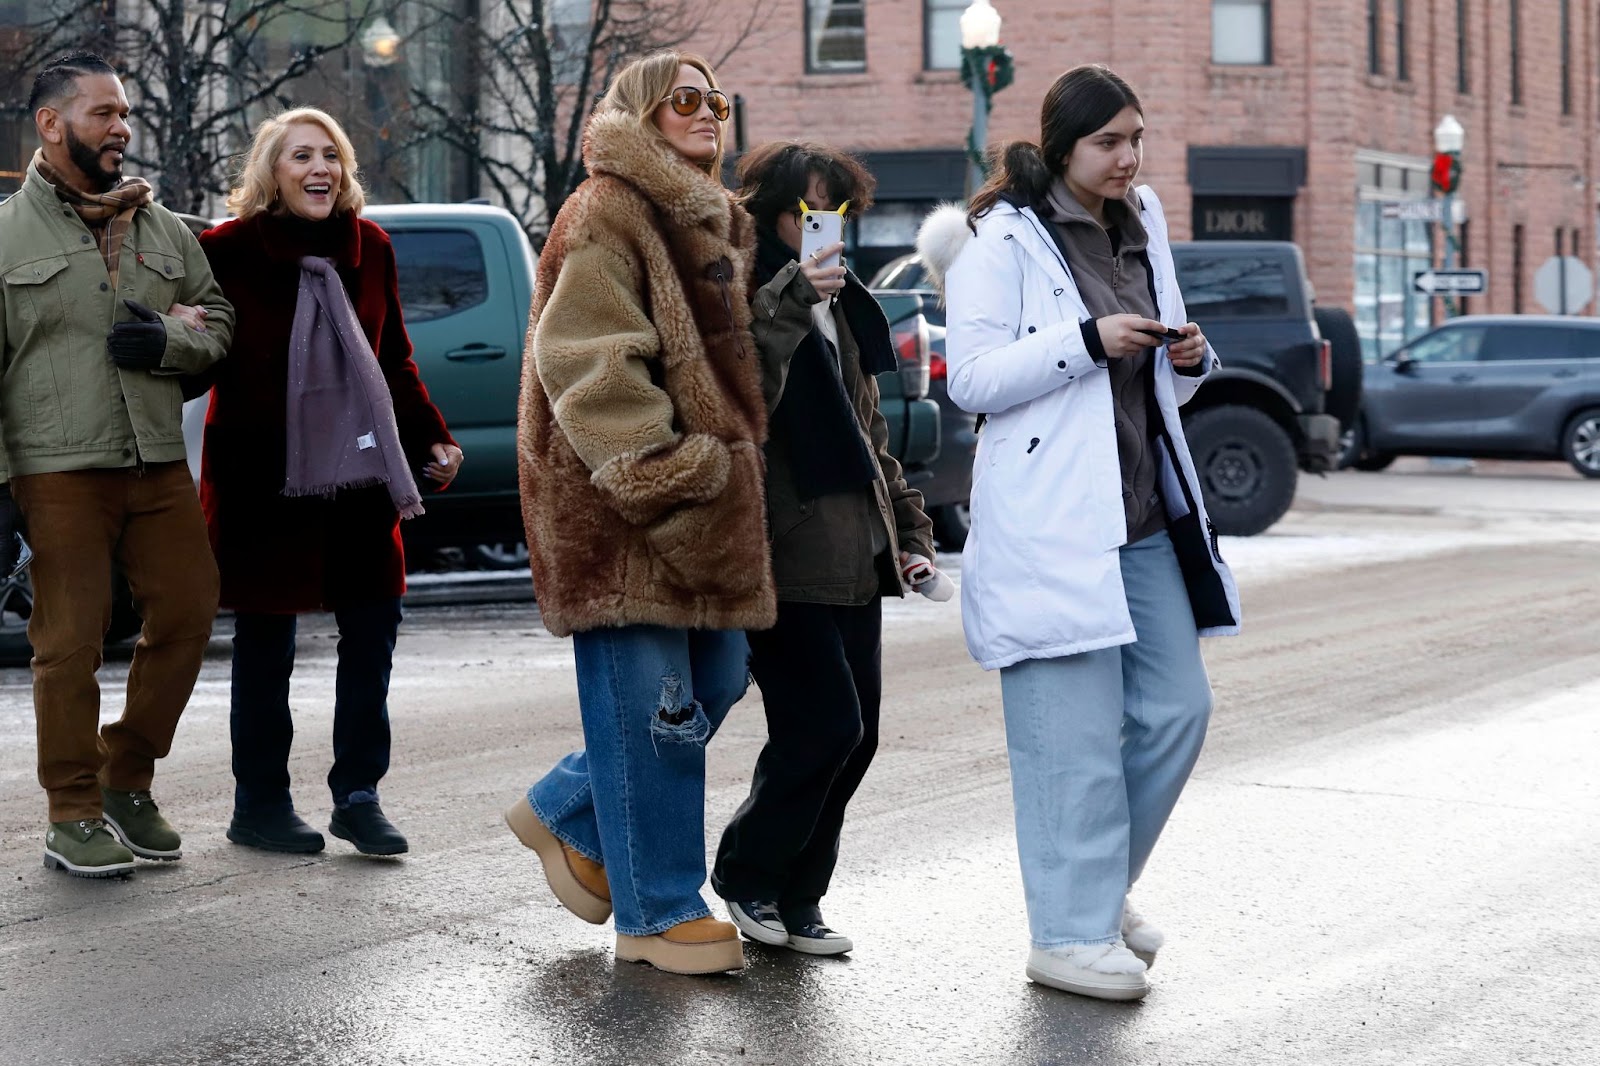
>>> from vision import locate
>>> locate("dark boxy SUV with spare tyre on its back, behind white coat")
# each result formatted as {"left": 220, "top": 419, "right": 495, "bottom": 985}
{"left": 872, "top": 240, "right": 1362, "bottom": 536}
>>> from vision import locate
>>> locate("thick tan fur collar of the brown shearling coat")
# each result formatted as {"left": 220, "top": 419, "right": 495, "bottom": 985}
{"left": 584, "top": 110, "right": 731, "bottom": 237}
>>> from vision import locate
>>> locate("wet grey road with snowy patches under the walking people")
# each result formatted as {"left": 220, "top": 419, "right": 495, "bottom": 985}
{"left": 0, "top": 464, "right": 1600, "bottom": 1066}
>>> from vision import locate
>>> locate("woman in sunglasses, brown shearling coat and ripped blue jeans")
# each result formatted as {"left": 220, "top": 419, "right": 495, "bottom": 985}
{"left": 506, "top": 53, "right": 776, "bottom": 973}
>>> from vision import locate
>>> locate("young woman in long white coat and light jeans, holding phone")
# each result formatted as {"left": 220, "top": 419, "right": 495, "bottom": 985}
{"left": 918, "top": 66, "right": 1238, "bottom": 999}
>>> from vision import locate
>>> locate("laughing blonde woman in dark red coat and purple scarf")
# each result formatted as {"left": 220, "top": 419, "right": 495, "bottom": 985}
{"left": 200, "top": 109, "right": 461, "bottom": 855}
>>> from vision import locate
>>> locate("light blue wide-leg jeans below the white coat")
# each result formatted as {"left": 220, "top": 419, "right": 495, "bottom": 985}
{"left": 1000, "top": 531, "right": 1211, "bottom": 949}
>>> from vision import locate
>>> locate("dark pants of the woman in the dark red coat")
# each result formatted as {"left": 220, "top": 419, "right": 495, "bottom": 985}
{"left": 229, "top": 600, "right": 402, "bottom": 812}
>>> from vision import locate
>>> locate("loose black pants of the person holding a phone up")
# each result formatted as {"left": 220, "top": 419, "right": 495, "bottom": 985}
{"left": 710, "top": 599, "right": 883, "bottom": 912}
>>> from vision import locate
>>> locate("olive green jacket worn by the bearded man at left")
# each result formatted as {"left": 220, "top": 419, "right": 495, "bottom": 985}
{"left": 0, "top": 166, "right": 234, "bottom": 482}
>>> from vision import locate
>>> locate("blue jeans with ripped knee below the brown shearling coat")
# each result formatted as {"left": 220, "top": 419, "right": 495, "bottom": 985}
{"left": 528, "top": 626, "right": 750, "bottom": 936}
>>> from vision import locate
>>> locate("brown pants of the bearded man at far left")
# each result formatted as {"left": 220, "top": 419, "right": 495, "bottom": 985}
{"left": 11, "top": 463, "right": 218, "bottom": 821}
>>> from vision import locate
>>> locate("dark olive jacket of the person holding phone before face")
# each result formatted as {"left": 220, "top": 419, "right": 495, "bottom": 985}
{"left": 750, "top": 262, "right": 934, "bottom": 605}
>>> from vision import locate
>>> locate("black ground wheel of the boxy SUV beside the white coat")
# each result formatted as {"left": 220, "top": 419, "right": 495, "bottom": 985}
{"left": 1184, "top": 403, "right": 1299, "bottom": 536}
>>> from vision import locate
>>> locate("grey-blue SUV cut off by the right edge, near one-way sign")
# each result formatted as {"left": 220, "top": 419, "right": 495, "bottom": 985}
{"left": 1352, "top": 308, "right": 1600, "bottom": 477}
